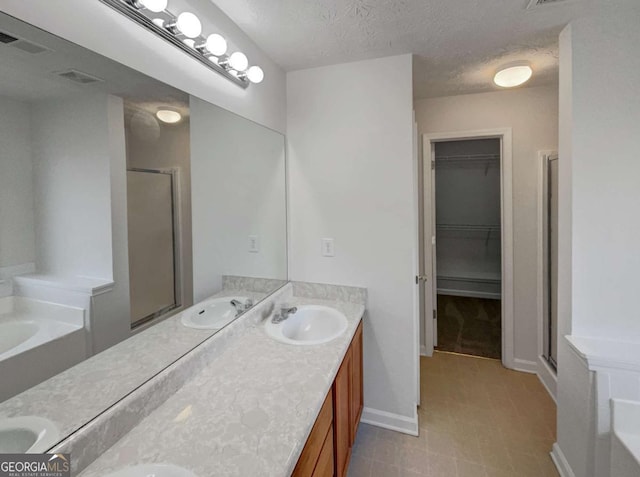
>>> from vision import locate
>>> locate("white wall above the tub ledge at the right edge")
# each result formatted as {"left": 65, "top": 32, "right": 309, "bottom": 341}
{"left": 561, "top": 12, "right": 640, "bottom": 340}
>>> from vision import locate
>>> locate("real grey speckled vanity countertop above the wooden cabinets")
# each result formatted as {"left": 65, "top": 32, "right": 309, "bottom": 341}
{"left": 80, "top": 291, "right": 366, "bottom": 477}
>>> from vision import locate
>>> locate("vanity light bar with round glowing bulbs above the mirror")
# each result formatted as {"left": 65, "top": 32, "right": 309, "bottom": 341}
{"left": 100, "top": 0, "right": 264, "bottom": 89}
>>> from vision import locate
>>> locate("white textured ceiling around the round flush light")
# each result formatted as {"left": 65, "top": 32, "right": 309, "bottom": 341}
{"left": 213, "top": 0, "right": 638, "bottom": 98}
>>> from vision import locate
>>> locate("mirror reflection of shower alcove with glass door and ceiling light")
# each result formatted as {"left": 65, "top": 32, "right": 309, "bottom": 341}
{"left": 125, "top": 100, "right": 193, "bottom": 328}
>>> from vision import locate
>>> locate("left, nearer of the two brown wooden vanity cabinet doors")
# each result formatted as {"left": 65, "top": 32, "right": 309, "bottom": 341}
{"left": 333, "top": 348, "right": 352, "bottom": 477}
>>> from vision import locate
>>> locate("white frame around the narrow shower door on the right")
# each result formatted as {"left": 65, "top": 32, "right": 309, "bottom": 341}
{"left": 537, "top": 149, "right": 558, "bottom": 400}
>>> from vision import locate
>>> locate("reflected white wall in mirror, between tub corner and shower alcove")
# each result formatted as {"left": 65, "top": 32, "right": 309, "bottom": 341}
{"left": 32, "top": 95, "right": 113, "bottom": 279}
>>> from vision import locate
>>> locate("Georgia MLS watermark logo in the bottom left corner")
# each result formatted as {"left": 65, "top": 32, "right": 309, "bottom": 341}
{"left": 0, "top": 454, "right": 71, "bottom": 477}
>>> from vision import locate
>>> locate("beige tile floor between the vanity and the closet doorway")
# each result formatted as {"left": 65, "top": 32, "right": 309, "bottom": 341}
{"left": 349, "top": 352, "right": 558, "bottom": 477}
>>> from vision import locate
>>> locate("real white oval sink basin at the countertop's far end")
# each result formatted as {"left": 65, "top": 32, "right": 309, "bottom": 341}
{"left": 265, "top": 305, "right": 347, "bottom": 345}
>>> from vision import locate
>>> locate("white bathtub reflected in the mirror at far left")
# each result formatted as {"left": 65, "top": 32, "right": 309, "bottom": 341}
{"left": 0, "top": 296, "right": 87, "bottom": 402}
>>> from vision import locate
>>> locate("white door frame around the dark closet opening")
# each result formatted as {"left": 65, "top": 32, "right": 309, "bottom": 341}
{"left": 418, "top": 128, "right": 516, "bottom": 369}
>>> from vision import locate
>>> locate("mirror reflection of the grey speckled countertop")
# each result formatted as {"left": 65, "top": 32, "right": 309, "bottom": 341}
{"left": 0, "top": 282, "right": 268, "bottom": 439}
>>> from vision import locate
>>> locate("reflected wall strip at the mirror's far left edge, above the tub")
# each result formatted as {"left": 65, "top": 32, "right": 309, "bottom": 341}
{"left": 0, "top": 96, "right": 35, "bottom": 268}
